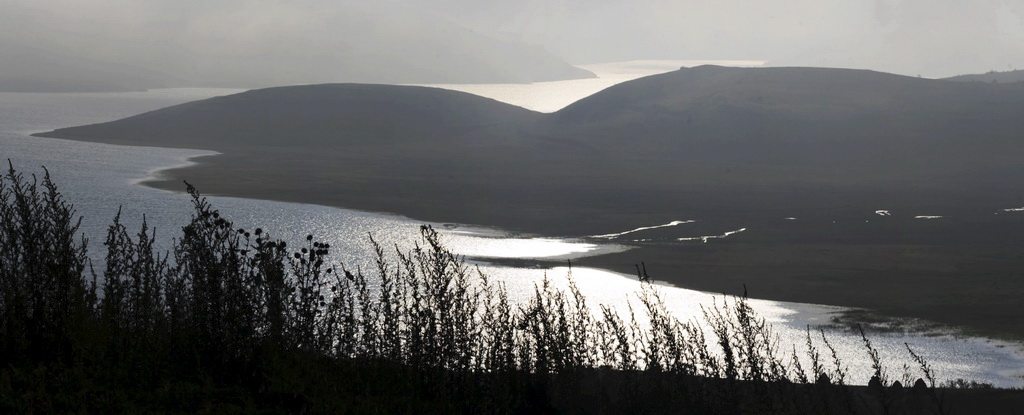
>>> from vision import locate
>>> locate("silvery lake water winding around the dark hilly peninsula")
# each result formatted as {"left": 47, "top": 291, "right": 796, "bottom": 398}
{"left": 0, "top": 61, "right": 1024, "bottom": 386}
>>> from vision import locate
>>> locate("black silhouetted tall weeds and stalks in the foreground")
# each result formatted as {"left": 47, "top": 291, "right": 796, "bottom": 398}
{"left": 0, "top": 162, "right": 1011, "bottom": 414}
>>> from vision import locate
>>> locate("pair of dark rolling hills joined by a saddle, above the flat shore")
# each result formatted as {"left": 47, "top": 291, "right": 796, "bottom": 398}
{"left": 36, "top": 66, "right": 1024, "bottom": 229}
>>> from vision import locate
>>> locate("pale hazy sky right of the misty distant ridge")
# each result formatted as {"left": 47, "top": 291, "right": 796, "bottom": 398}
{"left": 406, "top": 0, "right": 1024, "bottom": 77}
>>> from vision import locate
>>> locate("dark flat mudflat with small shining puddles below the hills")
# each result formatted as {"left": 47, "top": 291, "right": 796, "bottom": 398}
{"left": 145, "top": 155, "right": 1024, "bottom": 340}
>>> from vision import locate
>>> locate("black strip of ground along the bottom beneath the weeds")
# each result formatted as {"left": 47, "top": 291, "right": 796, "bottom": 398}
{"left": 8, "top": 355, "right": 1024, "bottom": 415}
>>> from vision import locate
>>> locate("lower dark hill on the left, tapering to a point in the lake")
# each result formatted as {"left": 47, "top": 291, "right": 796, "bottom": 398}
{"left": 46, "top": 84, "right": 540, "bottom": 148}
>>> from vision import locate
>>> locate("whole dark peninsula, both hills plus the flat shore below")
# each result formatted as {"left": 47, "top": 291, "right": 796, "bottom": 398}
{"left": 36, "top": 67, "right": 1024, "bottom": 338}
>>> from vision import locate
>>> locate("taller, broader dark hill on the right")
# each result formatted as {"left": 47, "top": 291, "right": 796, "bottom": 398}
{"left": 538, "top": 67, "right": 1024, "bottom": 190}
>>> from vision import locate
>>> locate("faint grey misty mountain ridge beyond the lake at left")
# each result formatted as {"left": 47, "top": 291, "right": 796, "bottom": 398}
{"left": 0, "top": 0, "right": 595, "bottom": 92}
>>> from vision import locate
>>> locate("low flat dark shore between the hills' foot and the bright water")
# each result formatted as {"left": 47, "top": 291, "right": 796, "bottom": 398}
{"left": 128, "top": 155, "right": 1024, "bottom": 341}
